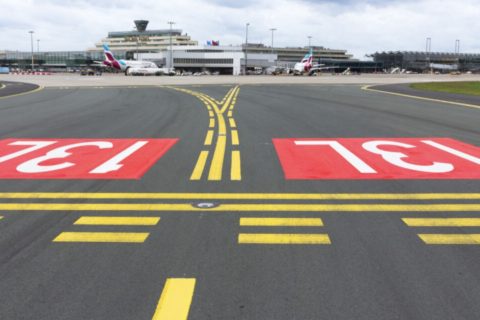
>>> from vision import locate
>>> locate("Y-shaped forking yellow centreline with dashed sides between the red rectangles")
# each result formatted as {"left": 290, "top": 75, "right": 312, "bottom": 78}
{"left": 170, "top": 85, "right": 242, "bottom": 181}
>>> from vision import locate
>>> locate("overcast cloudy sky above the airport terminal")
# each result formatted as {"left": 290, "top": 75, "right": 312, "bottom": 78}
{"left": 0, "top": 0, "right": 480, "bottom": 59}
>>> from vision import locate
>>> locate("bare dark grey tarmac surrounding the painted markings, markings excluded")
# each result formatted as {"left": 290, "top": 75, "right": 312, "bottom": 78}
{"left": 0, "top": 84, "right": 480, "bottom": 320}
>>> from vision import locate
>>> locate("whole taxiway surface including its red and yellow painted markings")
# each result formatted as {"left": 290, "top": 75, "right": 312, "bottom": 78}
{"left": 0, "top": 85, "right": 480, "bottom": 320}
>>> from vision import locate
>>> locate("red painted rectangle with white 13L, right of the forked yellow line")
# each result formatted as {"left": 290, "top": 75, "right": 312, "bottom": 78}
{"left": 273, "top": 138, "right": 480, "bottom": 180}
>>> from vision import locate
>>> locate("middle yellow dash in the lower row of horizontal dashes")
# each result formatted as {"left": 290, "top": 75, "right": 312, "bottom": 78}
{"left": 238, "top": 233, "right": 331, "bottom": 244}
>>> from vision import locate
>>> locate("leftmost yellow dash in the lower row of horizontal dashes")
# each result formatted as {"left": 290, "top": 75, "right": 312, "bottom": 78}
{"left": 53, "top": 232, "right": 149, "bottom": 243}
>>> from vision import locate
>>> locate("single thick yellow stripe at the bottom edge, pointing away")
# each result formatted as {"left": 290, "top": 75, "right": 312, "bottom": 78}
{"left": 152, "top": 278, "right": 195, "bottom": 320}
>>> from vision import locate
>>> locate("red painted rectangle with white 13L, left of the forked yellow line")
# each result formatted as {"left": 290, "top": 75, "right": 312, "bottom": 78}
{"left": 0, "top": 139, "right": 177, "bottom": 179}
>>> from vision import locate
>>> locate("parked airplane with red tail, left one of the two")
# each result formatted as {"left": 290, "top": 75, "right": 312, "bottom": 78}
{"left": 102, "top": 44, "right": 175, "bottom": 75}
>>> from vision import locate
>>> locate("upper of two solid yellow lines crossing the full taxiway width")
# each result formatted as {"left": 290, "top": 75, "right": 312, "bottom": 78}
{"left": 0, "top": 192, "right": 480, "bottom": 200}
